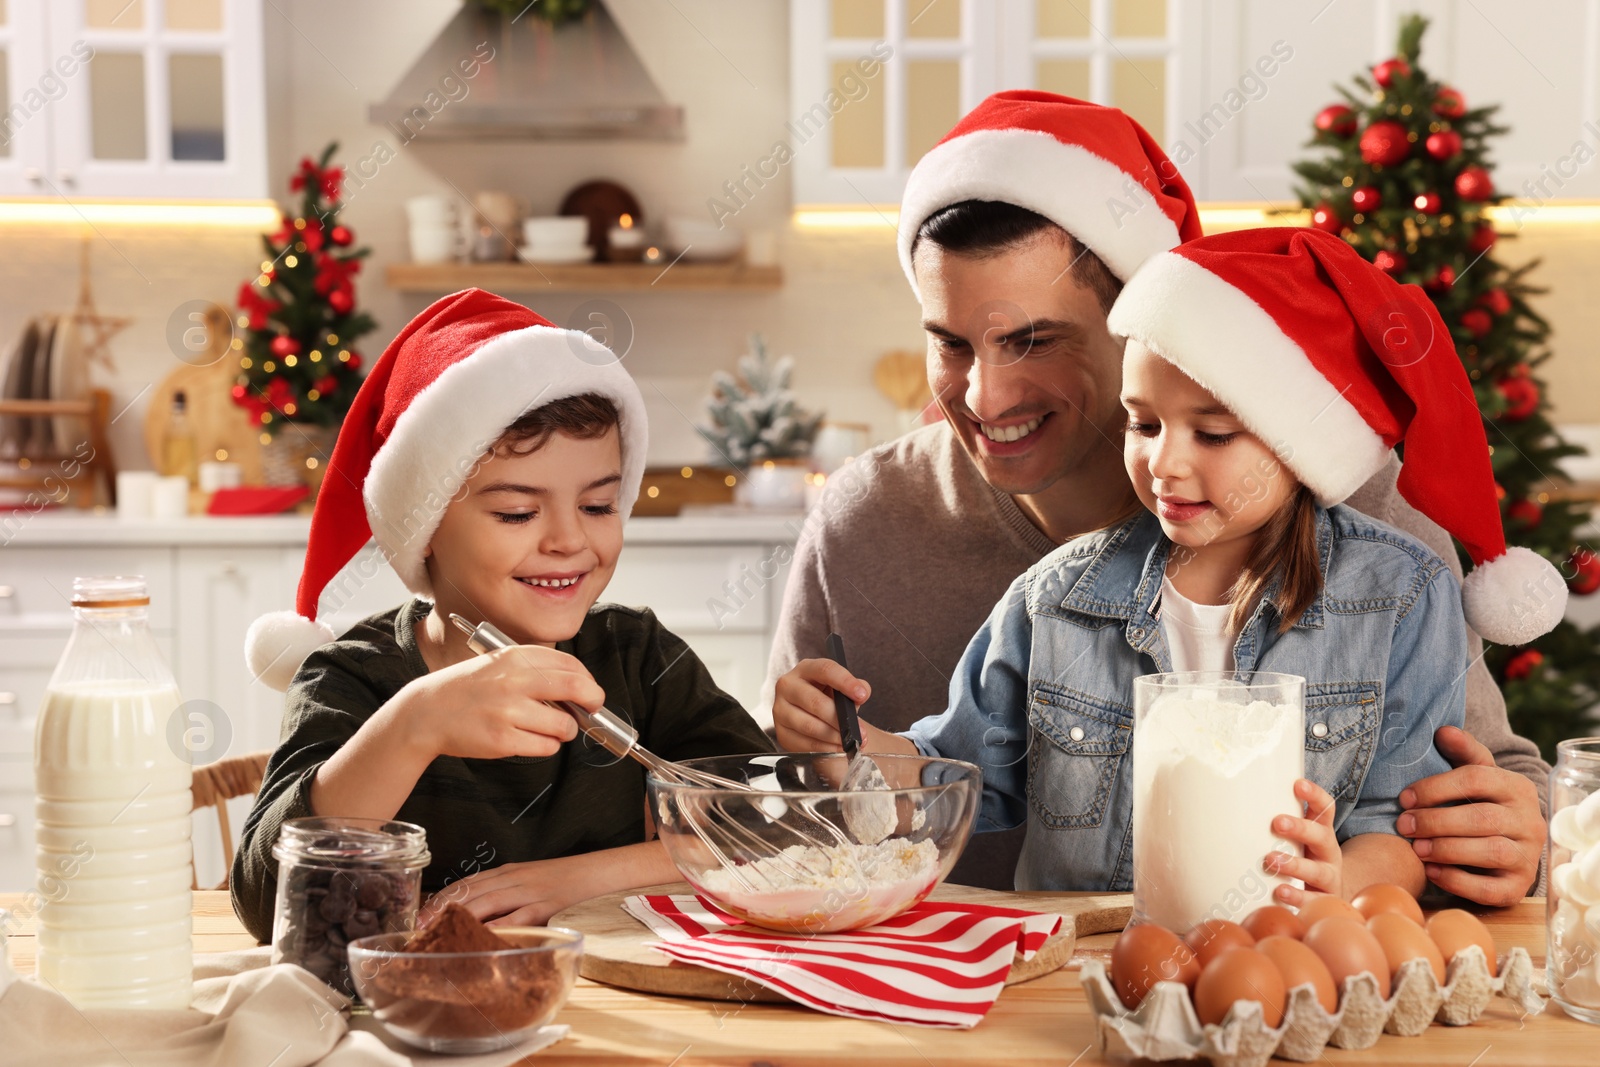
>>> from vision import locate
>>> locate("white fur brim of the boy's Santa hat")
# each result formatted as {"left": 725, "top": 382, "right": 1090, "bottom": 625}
{"left": 362, "top": 326, "right": 648, "bottom": 600}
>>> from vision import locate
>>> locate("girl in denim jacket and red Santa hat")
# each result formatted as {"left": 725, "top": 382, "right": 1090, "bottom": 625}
{"left": 774, "top": 229, "right": 1565, "bottom": 904}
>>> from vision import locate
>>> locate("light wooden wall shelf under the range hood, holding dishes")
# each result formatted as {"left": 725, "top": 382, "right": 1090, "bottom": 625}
{"left": 384, "top": 262, "right": 784, "bottom": 293}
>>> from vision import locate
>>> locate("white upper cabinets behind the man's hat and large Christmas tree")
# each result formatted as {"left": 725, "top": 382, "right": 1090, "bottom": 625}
{"left": 789, "top": 0, "right": 1600, "bottom": 208}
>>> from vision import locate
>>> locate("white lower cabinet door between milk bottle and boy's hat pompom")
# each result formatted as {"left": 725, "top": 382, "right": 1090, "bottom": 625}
{"left": 173, "top": 545, "right": 296, "bottom": 763}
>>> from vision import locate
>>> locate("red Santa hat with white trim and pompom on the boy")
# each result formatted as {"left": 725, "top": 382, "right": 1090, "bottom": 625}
{"left": 245, "top": 290, "right": 646, "bottom": 689}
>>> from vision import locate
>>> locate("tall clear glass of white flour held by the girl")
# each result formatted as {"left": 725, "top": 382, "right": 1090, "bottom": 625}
{"left": 1133, "top": 670, "right": 1306, "bottom": 934}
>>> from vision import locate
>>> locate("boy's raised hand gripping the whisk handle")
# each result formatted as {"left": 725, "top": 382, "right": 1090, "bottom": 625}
{"left": 406, "top": 645, "right": 605, "bottom": 760}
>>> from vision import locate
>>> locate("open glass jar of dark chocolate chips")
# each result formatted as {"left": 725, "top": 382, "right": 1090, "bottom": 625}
{"left": 272, "top": 817, "right": 429, "bottom": 997}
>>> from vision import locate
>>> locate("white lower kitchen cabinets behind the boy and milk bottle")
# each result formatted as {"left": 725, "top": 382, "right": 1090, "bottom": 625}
{"left": 0, "top": 512, "right": 800, "bottom": 891}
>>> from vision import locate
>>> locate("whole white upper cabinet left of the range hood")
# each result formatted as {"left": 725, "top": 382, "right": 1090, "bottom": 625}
{"left": 0, "top": 0, "right": 267, "bottom": 200}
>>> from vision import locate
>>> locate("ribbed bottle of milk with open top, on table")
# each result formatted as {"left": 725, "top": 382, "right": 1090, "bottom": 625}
{"left": 34, "top": 577, "right": 194, "bottom": 1008}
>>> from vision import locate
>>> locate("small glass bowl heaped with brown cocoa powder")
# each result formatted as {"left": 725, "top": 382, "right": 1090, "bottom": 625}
{"left": 349, "top": 904, "right": 584, "bottom": 1053}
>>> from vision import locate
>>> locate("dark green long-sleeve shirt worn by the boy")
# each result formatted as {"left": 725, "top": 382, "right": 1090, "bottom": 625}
{"left": 232, "top": 600, "right": 771, "bottom": 942}
